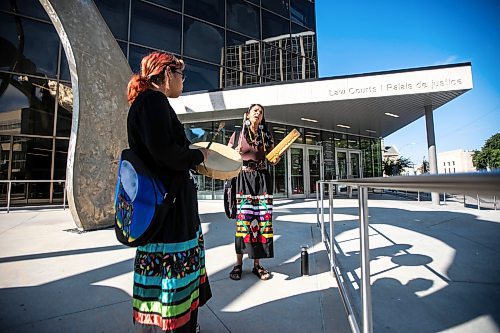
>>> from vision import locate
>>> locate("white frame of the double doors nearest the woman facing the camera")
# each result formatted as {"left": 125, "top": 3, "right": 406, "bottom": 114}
{"left": 287, "top": 144, "right": 324, "bottom": 198}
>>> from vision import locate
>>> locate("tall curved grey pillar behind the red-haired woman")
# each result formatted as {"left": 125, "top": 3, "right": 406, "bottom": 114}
{"left": 40, "top": 0, "right": 131, "bottom": 230}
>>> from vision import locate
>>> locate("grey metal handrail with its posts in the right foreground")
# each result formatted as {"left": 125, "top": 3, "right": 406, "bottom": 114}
{"left": 316, "top": 172, "right": 500, "bottom": 333}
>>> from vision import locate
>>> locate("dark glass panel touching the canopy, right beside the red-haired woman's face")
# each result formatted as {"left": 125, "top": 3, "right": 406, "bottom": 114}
{"left": 184, "top": 59, "right": 221, "bottom": 92}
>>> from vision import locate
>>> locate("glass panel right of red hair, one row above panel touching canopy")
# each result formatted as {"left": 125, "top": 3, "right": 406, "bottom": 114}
{"left": 184, "top": 18, "right": 224, "bottom": 64}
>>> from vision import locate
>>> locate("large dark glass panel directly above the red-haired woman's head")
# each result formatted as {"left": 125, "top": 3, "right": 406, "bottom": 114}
{"left": 130, "top": 2, "right": 181, "bottom": 54}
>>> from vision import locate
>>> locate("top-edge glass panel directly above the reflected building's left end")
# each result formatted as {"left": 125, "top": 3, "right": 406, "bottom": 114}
{"left": 227, "top": 0, "right": 260, "bottom": 39}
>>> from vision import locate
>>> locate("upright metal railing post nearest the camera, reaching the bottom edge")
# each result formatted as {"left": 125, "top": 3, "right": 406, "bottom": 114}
{"left": 358, "top": 186, "right": 373, "bottom": 333}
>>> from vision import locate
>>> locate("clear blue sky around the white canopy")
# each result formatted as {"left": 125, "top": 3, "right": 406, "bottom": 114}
{"left": 316, "top": 0, "right": 500, "bottom": 164}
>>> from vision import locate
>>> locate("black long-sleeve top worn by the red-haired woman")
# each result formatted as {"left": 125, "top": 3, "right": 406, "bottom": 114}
{"left": 127, "top": 90, "right": 203, "bottom": 243}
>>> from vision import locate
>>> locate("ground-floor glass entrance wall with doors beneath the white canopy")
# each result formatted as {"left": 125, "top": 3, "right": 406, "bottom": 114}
{"left": 185, "top": 119, "right": 382, "bottom": 199}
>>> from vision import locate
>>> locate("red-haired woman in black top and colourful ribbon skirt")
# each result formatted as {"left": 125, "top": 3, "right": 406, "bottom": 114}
{"left": 127, "top": 52, "right": 212, "bottom": 332}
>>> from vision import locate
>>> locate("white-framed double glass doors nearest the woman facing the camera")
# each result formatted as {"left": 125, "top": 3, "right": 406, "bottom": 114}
{"left": 287, "top": 144, "right": 323, "bottom": 198}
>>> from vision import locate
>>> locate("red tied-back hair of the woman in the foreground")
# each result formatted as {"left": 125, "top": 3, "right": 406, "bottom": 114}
{"left": 127, "top": 52, "right": 184, "bottom": 104}
